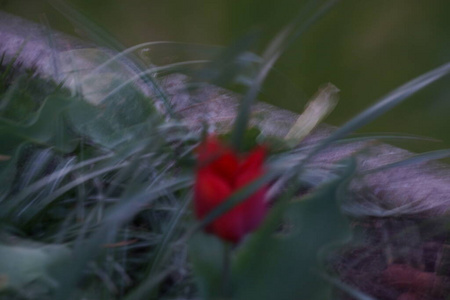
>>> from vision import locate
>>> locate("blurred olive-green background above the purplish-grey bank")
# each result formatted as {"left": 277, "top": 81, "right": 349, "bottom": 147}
{"left": 0, "top": 0, "right": 450, "bottom": 150}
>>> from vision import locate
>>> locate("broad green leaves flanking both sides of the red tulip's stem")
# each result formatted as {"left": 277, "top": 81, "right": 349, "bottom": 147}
{"left": 190, "top": 164, "right": 354, "bottom": 300}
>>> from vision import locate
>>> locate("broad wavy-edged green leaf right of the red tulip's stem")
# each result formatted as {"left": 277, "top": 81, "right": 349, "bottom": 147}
{"left": 233, "top": 162, "right": 354, "bottom": 300}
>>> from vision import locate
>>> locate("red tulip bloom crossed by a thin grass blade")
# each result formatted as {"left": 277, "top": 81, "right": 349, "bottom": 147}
{"left": 194, "top": 136, "right": 268, "bottom": 243}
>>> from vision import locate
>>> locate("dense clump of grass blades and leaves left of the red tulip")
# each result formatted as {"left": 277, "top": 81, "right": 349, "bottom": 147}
{"left": 0, "top": 55, "right": 195, "bottom": 299}
